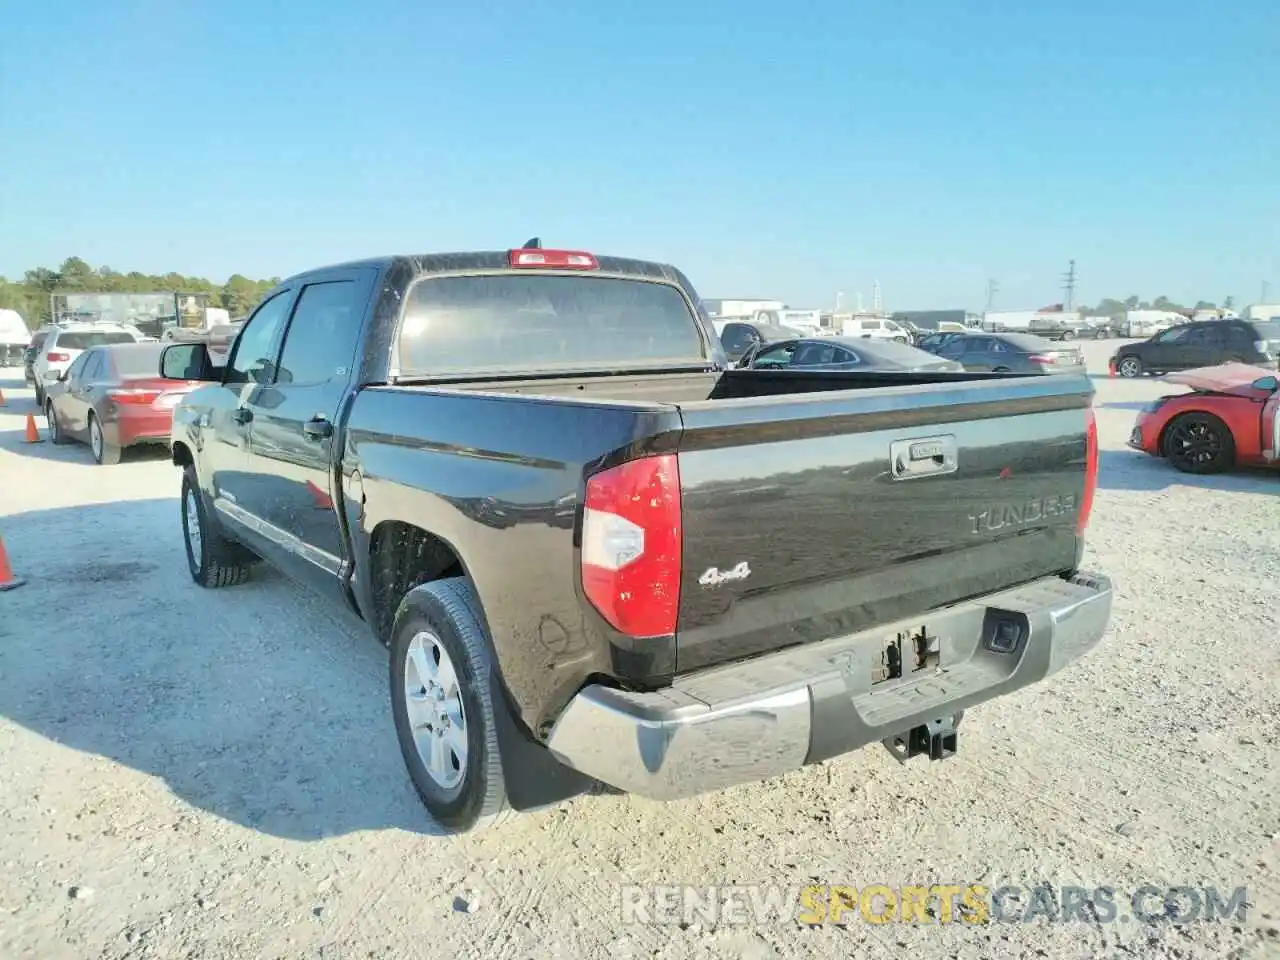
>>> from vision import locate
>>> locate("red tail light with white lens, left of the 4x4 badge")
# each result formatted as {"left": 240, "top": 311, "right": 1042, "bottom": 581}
{"left": 582, "top": 453, "right": 682, "bottom": 637}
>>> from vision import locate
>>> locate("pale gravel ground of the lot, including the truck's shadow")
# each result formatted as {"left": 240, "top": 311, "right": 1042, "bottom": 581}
{"left": 0, "top": 343, "right": 1280, "bottom": 960}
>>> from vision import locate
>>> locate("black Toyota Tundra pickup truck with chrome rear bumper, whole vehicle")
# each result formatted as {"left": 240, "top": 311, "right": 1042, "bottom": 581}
{"left": 161, "top": 244, "right": 1111, "bottom": 831}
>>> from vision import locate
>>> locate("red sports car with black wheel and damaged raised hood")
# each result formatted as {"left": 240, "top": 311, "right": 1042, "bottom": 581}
{"left": 1129, "top": 364, "right": 1280, "bottom": 474}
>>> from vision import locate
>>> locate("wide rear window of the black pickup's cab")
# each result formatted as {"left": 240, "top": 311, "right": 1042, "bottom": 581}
{"left": 397, "top": 273, "right": 710, "bottom": 376}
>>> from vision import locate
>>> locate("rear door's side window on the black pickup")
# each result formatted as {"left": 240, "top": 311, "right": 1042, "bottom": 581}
{"left": 275, "top": 280, "right": 361, "bottom": 385}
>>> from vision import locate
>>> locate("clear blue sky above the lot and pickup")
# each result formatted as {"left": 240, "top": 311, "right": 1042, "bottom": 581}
{"left": 0, "top": 0, "right": 1280, "bottom": 308}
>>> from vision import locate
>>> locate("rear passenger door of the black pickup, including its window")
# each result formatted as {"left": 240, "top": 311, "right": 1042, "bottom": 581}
{"left": 240, "top": 268, "right": 376, "bottom": 604}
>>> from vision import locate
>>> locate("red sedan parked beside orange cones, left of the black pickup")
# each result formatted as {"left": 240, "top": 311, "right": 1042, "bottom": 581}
{"left": 45, "top": 343, "right": 200, "bottom": 463}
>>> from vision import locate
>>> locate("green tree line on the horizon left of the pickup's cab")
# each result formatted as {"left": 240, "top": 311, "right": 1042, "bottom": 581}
{"left": 0, "top": 257, "right": 280, "bottom": 329}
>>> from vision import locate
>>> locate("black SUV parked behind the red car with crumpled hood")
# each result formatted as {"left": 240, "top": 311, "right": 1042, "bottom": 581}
{"left": 1108, "top": 319, "right": 1280, "bottom": 378}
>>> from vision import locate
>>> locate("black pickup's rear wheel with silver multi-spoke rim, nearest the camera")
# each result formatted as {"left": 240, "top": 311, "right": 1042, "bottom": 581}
{"left": 390, "top": 577, "right": 515, "bottom": 833}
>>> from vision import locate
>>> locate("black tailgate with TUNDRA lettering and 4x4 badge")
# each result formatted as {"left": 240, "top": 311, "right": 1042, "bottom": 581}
{"left": 677, "top": 375, "right": 1093, "bottom": 673}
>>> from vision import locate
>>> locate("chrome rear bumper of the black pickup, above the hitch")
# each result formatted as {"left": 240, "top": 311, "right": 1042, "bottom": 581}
{"left": 548, "top": 573, "right": 1111, "bottom": 800}
